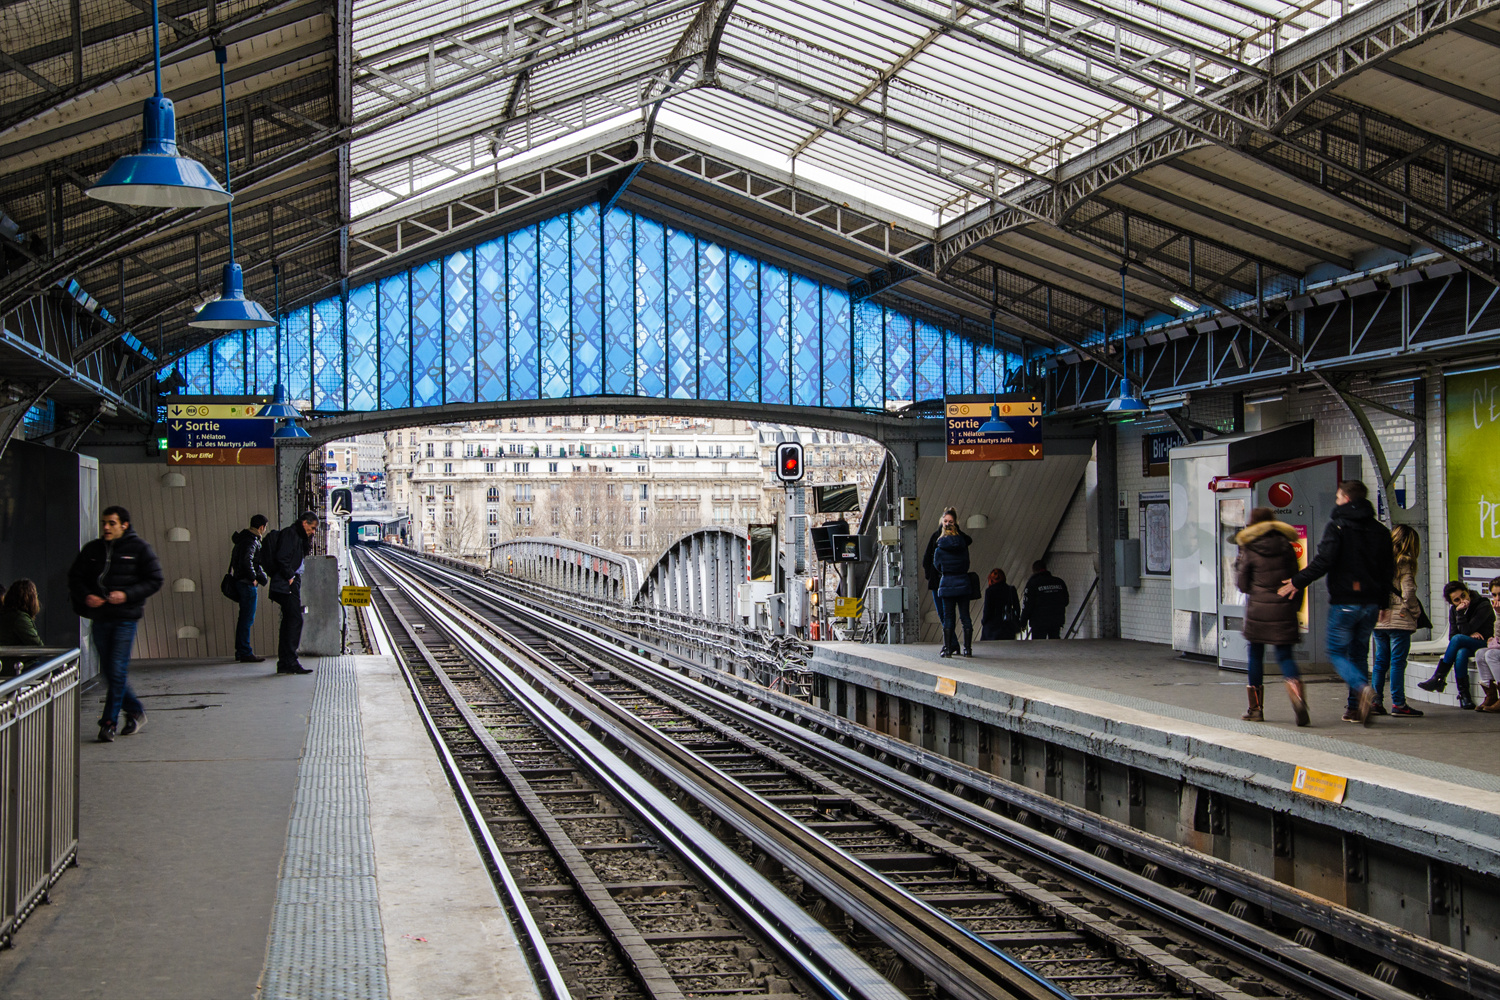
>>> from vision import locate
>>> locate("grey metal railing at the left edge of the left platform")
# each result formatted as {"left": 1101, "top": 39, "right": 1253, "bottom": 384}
{"left": 0, "top": 646, "right": 80, "bottom": 948}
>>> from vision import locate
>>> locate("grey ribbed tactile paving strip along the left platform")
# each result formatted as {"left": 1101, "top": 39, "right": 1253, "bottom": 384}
{"left": 260, "top": 657, "right": 390, "bottom": 1000}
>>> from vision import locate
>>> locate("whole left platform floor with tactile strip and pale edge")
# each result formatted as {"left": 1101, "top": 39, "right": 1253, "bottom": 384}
{"left": 0, "top": 657, "right": 536, "bottom": 1000}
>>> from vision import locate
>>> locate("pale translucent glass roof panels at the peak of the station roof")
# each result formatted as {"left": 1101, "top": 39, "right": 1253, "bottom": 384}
{"left": 351, "top": 0, "right": 1359, "bottom": 225}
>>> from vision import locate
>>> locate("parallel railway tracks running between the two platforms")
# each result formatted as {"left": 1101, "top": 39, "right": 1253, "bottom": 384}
{"left": 351, "top": 542, "right": 1476, "bottom": 1000}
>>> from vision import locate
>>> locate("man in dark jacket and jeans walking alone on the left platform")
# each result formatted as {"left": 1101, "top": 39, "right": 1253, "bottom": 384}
{"left": 68, "top": 507, "right": 164, "bottom": 744}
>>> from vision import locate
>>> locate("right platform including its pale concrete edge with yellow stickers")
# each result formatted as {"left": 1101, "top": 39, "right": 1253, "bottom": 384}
{"left": 813, "top": 640, "right": 1500, "bottom": 871}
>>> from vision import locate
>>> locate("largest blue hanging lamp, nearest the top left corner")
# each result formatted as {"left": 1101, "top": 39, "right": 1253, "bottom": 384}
{"left": 84, "top": 0, "right": 231, "bottom": 208}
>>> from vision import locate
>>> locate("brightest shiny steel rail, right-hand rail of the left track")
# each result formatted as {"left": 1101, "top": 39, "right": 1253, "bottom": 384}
{"left": 363, "top": 551, "right": 908, "bottom": 1000}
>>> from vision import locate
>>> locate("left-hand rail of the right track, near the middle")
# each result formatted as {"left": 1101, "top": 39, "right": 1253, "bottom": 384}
{"left": 375, "top": 551, "right": 1071, "bottom": 1000}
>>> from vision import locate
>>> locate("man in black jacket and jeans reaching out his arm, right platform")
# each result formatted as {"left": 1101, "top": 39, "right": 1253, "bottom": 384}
{"left": 1277, "top": 480, "right": 1397, "bottom": 726}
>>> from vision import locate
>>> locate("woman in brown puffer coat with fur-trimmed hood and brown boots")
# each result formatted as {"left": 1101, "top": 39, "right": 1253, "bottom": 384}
{"left": 1235, "top": 507, "right": 1308, "bottom": 726}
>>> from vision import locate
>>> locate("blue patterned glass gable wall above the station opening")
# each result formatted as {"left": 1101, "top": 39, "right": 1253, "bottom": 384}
{"left": 178, "top": 204, "right": 1020, "bottom": 412}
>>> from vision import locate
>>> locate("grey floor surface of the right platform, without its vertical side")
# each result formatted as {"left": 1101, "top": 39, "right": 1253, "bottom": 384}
{"left": 821, "top": 639, "right": 1500, "bottom": 792}
